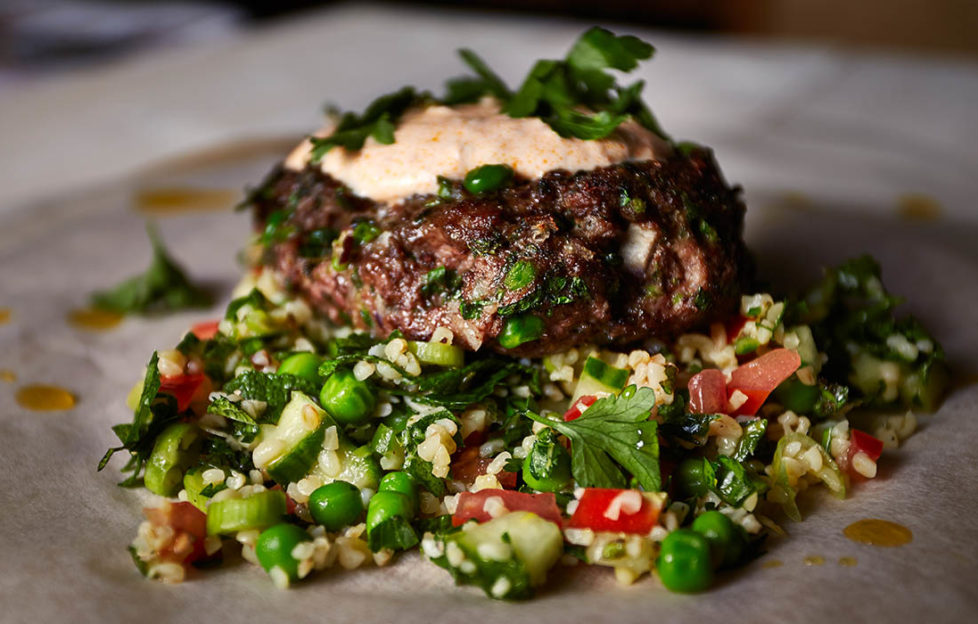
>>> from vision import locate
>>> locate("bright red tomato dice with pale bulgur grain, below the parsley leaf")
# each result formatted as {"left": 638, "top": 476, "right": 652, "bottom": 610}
{"left": 567, "top": 488, "right": 659, "bottom": 535}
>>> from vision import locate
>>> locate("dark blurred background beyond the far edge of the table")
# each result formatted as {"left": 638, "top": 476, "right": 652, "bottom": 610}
{"left": 0, "top": 0, "right": 978, "bottom": 89}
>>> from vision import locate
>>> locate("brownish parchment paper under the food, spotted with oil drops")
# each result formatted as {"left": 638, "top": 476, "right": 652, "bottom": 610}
{"left": 0, "top": 141, "right": 978, "bottom": 624}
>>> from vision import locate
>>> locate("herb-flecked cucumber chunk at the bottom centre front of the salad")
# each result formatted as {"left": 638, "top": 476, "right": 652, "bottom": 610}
{"left": 423, "top": 511, "right": 564, "bottom": 599}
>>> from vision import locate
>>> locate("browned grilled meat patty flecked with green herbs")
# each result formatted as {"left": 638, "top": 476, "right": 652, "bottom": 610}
{"left": 251, "top": 148, "right": 748, "bottom": 357}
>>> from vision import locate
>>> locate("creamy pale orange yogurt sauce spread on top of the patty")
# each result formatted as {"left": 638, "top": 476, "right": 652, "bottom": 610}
{"left": 285, "top": 99, "right": 670, "bottom": 202}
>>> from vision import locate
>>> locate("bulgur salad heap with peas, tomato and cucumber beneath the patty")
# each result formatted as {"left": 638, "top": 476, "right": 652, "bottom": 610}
{"left": 99, "top": 257, "right": 948, "bottom": 599}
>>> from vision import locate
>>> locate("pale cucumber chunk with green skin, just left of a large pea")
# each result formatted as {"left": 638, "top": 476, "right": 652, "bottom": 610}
{"left": 255, "top": 392, "right": 336, "bottom": 486}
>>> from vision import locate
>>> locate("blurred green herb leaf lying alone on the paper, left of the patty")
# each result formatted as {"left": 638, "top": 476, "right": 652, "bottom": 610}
{"left": 92, "top": 225, "right": 211, "bottom": 314}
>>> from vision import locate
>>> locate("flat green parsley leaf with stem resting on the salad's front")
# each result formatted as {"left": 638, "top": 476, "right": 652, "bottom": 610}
{"left": 527, "top": 386, "right": 662, "bottom": 492}
